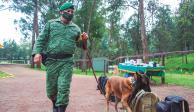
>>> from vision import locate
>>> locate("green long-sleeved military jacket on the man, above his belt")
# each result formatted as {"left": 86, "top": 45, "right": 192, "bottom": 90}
{"left": 33, "top": 18, "right": 82, "bottom": 54}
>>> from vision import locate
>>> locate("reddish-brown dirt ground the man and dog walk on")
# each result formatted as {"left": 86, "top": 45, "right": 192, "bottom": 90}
{"left": 0, "top": 65, "right": 194, "bottom": 112}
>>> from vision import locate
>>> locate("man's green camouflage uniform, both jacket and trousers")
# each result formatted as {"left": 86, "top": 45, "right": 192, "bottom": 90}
{"left": 33, "top": 18, "right": 82, "bottom": 106}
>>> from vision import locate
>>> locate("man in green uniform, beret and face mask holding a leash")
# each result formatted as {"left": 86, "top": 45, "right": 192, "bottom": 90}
{"left": 33, "top": 2, "right": 88, "bottom": 112}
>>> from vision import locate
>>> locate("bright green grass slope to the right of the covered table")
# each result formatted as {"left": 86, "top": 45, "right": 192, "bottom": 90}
{"left": 148, "top": 53, "right": 194, "bottom": 88}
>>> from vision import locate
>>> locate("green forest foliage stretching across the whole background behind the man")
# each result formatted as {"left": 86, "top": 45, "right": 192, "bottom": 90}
{"left": 0, "top": 0, "right": 194, "bottom": 59}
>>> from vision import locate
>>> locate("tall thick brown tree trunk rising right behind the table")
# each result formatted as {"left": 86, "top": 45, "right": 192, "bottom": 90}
{"left": 139, "top": 0, "right": 149, "bottom": 63}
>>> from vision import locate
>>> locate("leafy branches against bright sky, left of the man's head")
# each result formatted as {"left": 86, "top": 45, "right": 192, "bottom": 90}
{"left": 10, "top": 0, "right": 70, "bottom": 38}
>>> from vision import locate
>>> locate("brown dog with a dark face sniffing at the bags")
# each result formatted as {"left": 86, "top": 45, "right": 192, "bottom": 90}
{"left": 105, "top": 71, "right": 151, "bottom": 112}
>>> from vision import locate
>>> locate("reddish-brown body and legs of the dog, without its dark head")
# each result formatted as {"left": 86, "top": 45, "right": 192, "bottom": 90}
{"left": 105, "top": 76, "right": 132, "bottom": 112}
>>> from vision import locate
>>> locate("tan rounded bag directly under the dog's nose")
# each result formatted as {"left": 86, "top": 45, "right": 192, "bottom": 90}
{"left": 130, "top": 89, "right": 159, "bottom": 112}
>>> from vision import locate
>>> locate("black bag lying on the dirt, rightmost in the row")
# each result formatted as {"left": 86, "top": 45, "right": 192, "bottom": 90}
{"left": 156, "top": 96, "right": 189, "bottom": 112}
